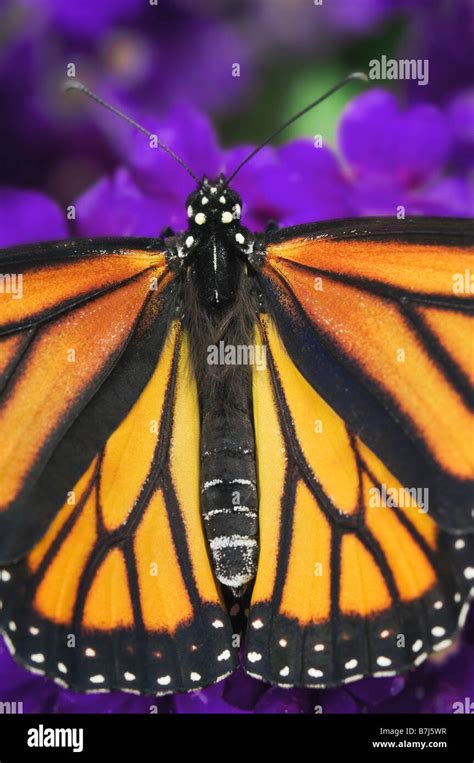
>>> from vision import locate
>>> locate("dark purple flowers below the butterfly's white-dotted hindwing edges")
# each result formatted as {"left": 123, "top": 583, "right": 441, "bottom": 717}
{"left": 0, "top": 610, "right": 474, "bottom": 715}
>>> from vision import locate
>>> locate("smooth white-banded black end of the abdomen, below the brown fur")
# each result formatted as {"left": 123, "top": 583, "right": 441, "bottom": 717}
{"left": 201, "top": 404, "right": 258, "bottom": 595}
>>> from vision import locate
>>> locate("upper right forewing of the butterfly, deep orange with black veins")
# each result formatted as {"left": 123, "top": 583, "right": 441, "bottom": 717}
{"left": 261, "top": 218, "right": 474, "bottom": 530}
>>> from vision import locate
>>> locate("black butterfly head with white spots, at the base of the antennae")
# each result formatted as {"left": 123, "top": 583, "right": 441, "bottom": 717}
{"left": 186, "top": 175, "right": 242, "bottom": 230}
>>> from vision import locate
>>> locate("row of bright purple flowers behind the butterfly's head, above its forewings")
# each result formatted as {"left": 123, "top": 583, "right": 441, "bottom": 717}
{"left": 0, "top": 88, "right": 474, "bottom": 245}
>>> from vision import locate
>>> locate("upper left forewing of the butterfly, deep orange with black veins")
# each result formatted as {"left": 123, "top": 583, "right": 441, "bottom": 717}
{"left": 0, "top": 240, "right": 172, "bottom": 562}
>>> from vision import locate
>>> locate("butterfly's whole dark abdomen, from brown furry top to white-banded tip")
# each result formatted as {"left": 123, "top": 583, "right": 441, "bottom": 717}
{"left": 183, "top": 256, "right": 258, "bottom": 595}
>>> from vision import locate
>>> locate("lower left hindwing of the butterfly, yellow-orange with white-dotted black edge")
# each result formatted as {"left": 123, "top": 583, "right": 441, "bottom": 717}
{"left": 0, "top": 324, "right": 237, "bottom": 694}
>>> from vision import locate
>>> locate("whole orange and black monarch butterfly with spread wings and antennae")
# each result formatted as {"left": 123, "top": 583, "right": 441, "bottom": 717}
{"left": 0, "top": 75, "right": 474, "bottom": 694}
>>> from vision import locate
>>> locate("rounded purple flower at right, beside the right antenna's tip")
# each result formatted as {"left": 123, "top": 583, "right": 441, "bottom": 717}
{"left": 339, "top": 88, "right": 473, "bottom": 216}
